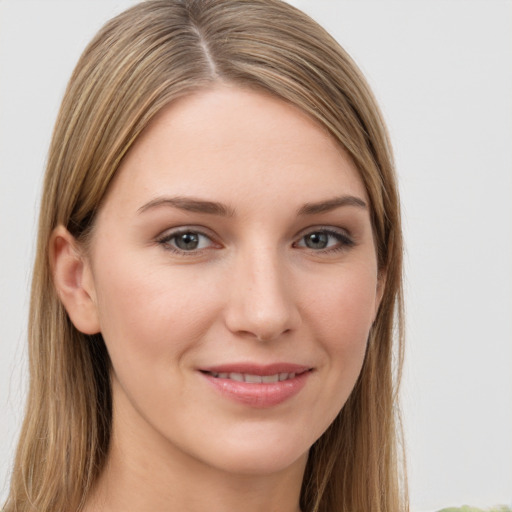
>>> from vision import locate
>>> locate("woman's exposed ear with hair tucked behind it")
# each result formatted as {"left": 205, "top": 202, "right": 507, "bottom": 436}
{"left": 50, "top": 226, "right": 100, "bottom": 334}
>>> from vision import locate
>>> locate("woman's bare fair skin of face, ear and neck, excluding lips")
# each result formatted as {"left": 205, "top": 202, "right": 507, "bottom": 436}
{"left": 52, "top": 85, "right": 382, "bottom": 512}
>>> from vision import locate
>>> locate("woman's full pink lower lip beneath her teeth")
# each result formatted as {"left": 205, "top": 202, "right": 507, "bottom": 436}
{"left": 202, "top": 371, "right": 311, "bottom": 408}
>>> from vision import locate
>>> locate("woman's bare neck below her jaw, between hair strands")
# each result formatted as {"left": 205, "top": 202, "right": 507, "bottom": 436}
{"left": 84, "top": 390, "right": 307, "bottom": 512}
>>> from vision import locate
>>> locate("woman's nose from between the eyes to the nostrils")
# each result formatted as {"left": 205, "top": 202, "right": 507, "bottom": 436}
{"left": 225, "top": 249, "right": 301, "bottom": 341}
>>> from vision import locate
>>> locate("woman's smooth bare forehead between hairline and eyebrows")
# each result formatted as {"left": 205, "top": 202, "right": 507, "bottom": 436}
{"left": 100, "top": 85, "right": 366, "bottom": 213}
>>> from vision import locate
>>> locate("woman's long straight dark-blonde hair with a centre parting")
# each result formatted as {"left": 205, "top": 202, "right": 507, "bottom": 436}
{"left": 5, "top": 0, "right": 407, "bottom": 512}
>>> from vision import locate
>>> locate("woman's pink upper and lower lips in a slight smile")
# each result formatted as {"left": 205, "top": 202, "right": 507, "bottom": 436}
{"left": 200, "top": 363, "right": 313, "bottom": 408}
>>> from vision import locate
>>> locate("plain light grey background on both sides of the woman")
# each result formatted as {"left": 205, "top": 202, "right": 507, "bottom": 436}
{"left": 0, "top": 0, "right": 512, "bottom": 511}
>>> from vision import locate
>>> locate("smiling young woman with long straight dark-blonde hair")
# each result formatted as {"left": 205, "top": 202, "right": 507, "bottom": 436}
{"left": 6, "top": 0, "right": 407, "bottom": 512}
